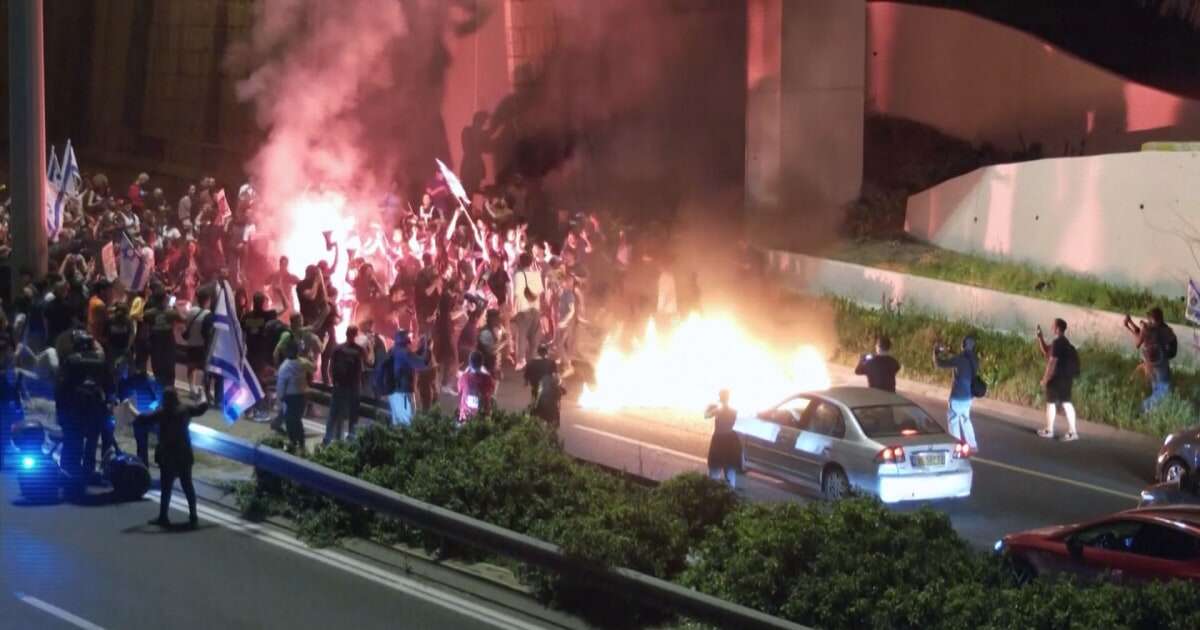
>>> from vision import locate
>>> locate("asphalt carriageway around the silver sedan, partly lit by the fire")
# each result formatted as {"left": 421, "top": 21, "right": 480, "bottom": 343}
{"left": 482, "top": 377, "right": 1157, "bottom": 547}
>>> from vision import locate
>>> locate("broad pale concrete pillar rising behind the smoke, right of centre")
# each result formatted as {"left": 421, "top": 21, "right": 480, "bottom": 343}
{"left": 745, "top": 0, "right": 866, "bottom": 237}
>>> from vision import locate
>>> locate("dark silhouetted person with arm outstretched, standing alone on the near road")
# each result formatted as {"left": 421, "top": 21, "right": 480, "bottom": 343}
{"left": 133, "top": 389, "right": 209, "bottom": 529}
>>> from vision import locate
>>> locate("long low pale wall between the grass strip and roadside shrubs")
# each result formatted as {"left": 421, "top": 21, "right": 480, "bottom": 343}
{"left": 769, "top": 251, "right": 1200, "bottom": 367}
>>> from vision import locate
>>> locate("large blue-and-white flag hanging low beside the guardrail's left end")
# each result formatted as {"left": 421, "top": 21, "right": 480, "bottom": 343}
{"left": 208, "top": 281, "right": 263, "bottom": 422}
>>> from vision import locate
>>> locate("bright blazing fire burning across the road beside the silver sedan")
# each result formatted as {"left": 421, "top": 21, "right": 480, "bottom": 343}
{"left": 580, "top": 314, "right": 830, "bottom": 414}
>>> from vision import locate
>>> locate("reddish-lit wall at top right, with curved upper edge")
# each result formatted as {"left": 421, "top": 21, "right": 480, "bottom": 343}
{"left": 866, "top": 2, "right": 1200, "bottom": 155}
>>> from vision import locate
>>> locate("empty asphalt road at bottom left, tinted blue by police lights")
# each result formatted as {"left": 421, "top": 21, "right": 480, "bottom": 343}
{"left": 0, "top": 472, "right": 568, "bottom": 630}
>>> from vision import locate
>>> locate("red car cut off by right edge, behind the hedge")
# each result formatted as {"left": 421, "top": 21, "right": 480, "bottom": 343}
{"left": 996, "top": 505, "right": 1200, "bottom": 582}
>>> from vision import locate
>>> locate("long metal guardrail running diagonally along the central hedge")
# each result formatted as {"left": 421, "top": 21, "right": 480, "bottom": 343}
{"left": 191, "top": 425, "right": 810, "bottom": 630}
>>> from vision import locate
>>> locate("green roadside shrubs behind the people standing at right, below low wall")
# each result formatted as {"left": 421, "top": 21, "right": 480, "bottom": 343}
{"left": 832, "top": 299, "right": 1200, "bottom": 437}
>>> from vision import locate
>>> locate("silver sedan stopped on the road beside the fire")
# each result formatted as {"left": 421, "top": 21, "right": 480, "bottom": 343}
{"left": 734, "top": 388, "right": 973, "bottom": 503}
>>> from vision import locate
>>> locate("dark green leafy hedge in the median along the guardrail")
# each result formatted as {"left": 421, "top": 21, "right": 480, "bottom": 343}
{"left": 239, "top": 413, "right": 1200, "bottom": 629}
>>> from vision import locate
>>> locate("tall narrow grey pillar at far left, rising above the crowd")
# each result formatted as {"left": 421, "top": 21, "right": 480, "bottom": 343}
{"left": 8, "top": 0, "right": 49, "bottom": 287}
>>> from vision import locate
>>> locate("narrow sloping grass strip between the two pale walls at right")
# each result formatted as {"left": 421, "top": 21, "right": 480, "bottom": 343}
{"left": 826, "top": 240, "right": 1184, "bottom": 323}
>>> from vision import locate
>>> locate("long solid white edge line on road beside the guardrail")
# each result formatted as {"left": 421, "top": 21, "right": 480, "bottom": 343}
{"left": 146, "top": 491, "right": 541, "bottom": 630}
